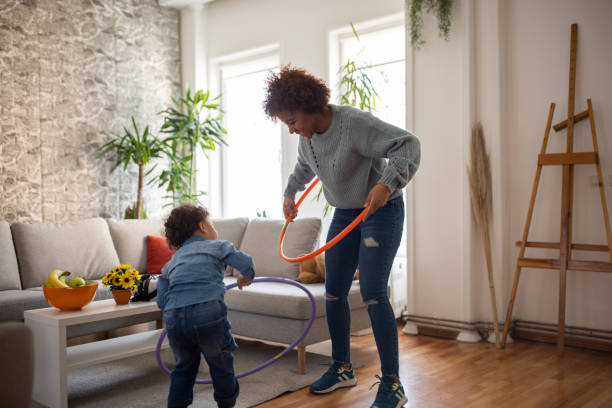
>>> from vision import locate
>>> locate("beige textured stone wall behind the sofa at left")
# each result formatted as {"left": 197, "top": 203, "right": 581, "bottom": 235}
{"left": 0, "top": 0, "right": 180, "bottom": 222}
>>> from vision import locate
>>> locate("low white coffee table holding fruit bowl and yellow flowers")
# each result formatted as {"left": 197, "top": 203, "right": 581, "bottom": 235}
{"left": 24, "top": 299, "right": 168, "bottom": 408}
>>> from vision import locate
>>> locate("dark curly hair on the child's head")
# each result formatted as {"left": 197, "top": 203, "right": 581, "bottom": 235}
{"left": 164, "top": 204, "right": 210, "bottom": 249}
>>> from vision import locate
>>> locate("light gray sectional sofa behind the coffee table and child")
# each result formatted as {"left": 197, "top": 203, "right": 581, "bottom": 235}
{"left": 0, "top": 218, "right": 370, "bottom": 372}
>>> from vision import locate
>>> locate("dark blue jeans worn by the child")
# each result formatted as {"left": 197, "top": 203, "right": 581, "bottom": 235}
{"left": 164, "top": 300, "right": 240, "bottom": 408}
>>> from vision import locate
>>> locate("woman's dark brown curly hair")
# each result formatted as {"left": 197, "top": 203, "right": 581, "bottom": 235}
{"left": 263, "top": 65, "right": 329, "bottom": 120}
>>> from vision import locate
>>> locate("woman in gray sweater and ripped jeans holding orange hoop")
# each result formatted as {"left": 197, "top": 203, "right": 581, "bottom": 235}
{"left": 264, "top": 66, "right": 420, "bottom": 408}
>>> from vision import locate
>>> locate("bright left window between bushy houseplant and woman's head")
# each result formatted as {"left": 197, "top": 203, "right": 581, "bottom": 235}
{"left": 220, "top": 55, "right": 282, "bottom": 218}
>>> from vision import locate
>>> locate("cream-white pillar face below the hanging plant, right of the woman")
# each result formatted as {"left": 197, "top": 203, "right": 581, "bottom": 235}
{"left": 408, "top": 3, "right": 469, "bottom": 320}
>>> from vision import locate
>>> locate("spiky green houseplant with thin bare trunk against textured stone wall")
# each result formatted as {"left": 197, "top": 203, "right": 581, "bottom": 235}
{"left": 99, "top": 116, "right": 164, "bottom": 218}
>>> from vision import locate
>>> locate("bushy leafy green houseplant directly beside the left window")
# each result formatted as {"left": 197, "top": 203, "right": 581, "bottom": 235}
{"left": 151, "top": 89, "right": 227, "bottom": 203}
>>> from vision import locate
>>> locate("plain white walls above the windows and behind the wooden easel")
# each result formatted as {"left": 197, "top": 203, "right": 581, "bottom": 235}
{"left": 176, "top": 0, "right": 612, "bottom": 330}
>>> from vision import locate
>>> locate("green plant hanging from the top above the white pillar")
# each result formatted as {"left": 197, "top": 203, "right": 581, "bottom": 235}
{"left": 406, "top": 0, "right": 453, "bottom": 49}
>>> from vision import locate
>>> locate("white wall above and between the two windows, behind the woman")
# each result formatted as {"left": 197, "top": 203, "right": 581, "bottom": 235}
{"left": 204, "top": 0, "right": 404, "bottom": 216}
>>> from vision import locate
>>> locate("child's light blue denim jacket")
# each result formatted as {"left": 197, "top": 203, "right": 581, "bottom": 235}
{"left": 157, "top": 235, "right": 255, "bottom": 310}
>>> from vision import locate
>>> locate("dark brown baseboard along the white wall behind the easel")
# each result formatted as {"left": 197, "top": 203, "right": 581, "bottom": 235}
{"left": 402, "top": 315, "right": 612, "bottom": 351}
